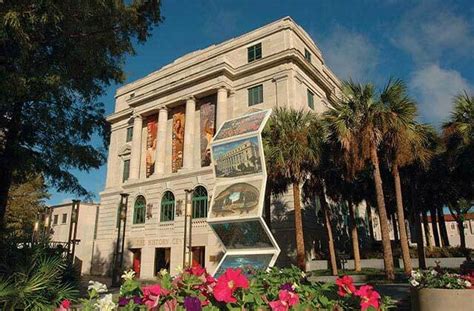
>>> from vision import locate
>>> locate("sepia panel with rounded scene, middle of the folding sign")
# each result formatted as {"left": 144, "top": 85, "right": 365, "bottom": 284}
{"left": 210, "top": 179, "right": 262, "bottom": 218}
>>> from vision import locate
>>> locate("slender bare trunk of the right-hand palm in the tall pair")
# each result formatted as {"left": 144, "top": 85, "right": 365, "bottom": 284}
{"left": 392, "top": 165, "right": 413, "bottom": 274}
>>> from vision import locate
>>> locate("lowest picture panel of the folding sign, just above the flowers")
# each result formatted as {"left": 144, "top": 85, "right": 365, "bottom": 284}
{"left": 214, "top": 254, "right": 273, "bottom": 277}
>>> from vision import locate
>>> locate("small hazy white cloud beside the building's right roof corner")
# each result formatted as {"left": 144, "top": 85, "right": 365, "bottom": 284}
{"left": 320, "top": 26, "right": 379, "bottom": 81}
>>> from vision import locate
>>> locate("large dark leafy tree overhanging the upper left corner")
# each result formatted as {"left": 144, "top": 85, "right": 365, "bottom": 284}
{"left": 0, "top": 0, "right": 162, "bottom": 224}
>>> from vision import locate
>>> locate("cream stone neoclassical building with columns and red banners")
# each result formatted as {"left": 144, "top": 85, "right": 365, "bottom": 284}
{"left": 93, "top": 17, "right": 339, "bottom": 278}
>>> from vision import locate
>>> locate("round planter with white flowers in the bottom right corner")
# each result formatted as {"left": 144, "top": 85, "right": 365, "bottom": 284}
{"left": 409, "top": 267, "right": 474, "bottom": 311}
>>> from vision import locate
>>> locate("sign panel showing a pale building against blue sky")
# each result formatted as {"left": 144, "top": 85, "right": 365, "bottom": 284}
{"left": 212, "top": 136, "right": 262, "bottom": 178}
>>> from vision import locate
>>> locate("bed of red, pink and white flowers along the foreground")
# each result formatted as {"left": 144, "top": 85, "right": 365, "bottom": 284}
{"left": 61, "top": 266, "right": 391, "bottom": 311}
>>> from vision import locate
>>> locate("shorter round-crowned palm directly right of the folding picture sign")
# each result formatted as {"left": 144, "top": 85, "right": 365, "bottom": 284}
{"left": 263, "top": 108, "right": 323, "bottom": 270}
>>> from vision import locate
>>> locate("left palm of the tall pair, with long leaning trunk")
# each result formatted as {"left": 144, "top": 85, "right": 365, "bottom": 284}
{"left": 325, "top": 81, "right": 395, "bottom": 280}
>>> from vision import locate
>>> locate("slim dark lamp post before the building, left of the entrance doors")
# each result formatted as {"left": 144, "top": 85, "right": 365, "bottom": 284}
{"left": 112, "top": 193, "right": 129, "bottom": 286}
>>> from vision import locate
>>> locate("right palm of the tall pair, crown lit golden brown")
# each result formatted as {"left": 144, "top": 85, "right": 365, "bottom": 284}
{"left": 380, "top": 79, "right": 431, "bottom": 274}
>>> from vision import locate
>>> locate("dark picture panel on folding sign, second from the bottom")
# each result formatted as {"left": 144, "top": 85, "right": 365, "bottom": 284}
{"left": 210, "top": 220, "right": 273, "bottom": 249}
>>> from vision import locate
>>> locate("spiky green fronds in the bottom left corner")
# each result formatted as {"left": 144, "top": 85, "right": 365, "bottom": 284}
{"left": 0, "top": 242, "right": 79, "bottom": 310}
